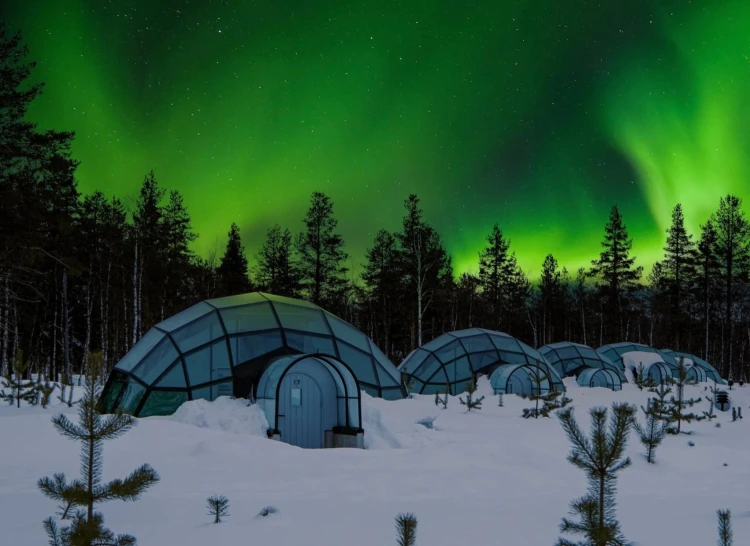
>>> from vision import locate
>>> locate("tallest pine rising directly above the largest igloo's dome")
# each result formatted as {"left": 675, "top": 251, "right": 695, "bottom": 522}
{"left": 297, "top": 192, "right": 348, "bottom": 309}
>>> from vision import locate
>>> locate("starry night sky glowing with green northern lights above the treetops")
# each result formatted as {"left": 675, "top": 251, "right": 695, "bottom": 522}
{"left": 3, "top": 0, "right": 750, "bottom": 276}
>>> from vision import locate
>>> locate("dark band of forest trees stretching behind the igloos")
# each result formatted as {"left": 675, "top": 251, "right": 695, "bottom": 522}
{"left": 0, "top": 27, "right": 750, "bottom": 380}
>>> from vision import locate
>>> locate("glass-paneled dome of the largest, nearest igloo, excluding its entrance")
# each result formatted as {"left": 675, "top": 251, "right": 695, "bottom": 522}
{"left": 101, "top": 292, "right": 405, "bottom": 417}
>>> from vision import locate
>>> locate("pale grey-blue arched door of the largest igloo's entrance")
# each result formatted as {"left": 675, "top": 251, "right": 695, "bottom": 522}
{"left": 278, "top": 372, "right": 324, "bottom": 449}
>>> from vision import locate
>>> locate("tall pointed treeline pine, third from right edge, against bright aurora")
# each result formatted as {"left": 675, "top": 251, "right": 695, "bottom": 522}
{"left": 663, "top": 204, "right": 695, "bottom": 351}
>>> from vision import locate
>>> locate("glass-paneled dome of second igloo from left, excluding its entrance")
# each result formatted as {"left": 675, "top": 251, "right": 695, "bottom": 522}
{"left": 398, "top": 328, "right": 565, "bottom": 395}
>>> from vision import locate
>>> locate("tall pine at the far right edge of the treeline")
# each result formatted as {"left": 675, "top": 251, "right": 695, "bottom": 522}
{"left": 710, "top": 195, "right": 750, "bottom": 367}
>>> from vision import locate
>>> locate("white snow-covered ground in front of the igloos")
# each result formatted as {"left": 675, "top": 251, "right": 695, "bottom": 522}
{"left": 0, "top": 379, "right": 750, "bottom": 546}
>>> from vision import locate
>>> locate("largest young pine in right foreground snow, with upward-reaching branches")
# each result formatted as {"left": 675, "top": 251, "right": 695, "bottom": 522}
{"left": 556, "top": 404, "right": 635, "bottom": 546}
